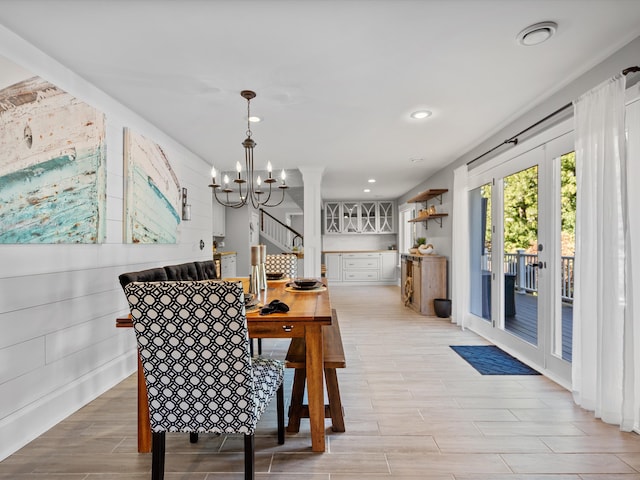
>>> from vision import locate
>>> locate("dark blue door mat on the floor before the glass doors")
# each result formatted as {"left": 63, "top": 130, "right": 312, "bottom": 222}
{"left": 450, "top": 345, "right": 540, "bottom": 375}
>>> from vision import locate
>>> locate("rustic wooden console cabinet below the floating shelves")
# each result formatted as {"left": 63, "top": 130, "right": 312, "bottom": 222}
{"left": 400, "top": 254, "right": 447, "bottom": 316}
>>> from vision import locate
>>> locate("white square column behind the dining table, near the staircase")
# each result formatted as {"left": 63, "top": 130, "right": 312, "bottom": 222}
{"left": 299, "top": 167, "right": 324, "bottom": 278}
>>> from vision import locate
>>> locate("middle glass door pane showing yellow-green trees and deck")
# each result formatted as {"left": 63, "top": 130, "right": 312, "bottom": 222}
{"left": 501, "top": 165, "right": 539, "bottom": 345}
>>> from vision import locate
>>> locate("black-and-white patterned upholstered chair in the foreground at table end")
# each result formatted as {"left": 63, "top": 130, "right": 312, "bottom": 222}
{"left": 125, "top": 281, "right": 284, "bottom": 480}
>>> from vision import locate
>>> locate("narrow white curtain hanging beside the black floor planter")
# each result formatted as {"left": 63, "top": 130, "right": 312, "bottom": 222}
{"left": 451, "top": 165, "right": 469, "bottom": 328}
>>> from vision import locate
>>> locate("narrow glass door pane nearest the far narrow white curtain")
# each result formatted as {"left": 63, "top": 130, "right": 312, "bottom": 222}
{"left": 469, "top": 183, "right": 492, "bottom": 321}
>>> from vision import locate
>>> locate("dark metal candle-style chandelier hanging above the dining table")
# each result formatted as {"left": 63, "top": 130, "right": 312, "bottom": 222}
{"left": 209, "top": 90, "right": 289, "bottom": 209}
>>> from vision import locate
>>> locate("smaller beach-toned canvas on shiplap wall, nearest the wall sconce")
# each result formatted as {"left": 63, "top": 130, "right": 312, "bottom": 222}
{"left": 124, "top": 128, "right": 181, "bottom": 243}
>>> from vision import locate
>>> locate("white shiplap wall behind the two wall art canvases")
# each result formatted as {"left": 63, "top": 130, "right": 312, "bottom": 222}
{"left": 0, "top": 26, "right": 211, "bottom": 460}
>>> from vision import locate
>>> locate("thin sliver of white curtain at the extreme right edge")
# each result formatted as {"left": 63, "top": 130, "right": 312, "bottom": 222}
{"left": 621, "top": 83, "right": 640, "bottom": 433}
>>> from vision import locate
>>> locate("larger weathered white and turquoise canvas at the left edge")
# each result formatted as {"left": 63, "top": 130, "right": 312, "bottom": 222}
{"left": 0, "top": 75, "right": 106, "bottom": 243}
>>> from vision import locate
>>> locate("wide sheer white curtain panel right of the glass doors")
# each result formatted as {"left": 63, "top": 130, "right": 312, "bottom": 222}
{"left": 572, "top": 74, "right": 634, "bottom": 429}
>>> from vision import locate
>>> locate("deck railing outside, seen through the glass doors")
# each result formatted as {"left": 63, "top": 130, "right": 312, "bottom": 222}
{"left": 482, "top": 250, "right": 574, "bottom": 303}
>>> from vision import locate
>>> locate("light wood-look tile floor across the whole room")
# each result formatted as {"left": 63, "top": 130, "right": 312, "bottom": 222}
{"left": 0, "top": 287, "right": 640, "bottom": 480}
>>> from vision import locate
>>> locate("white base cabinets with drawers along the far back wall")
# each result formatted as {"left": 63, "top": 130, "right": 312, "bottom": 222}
{"left": 324, "top": 251, "right": 398, "bottom": 285}
